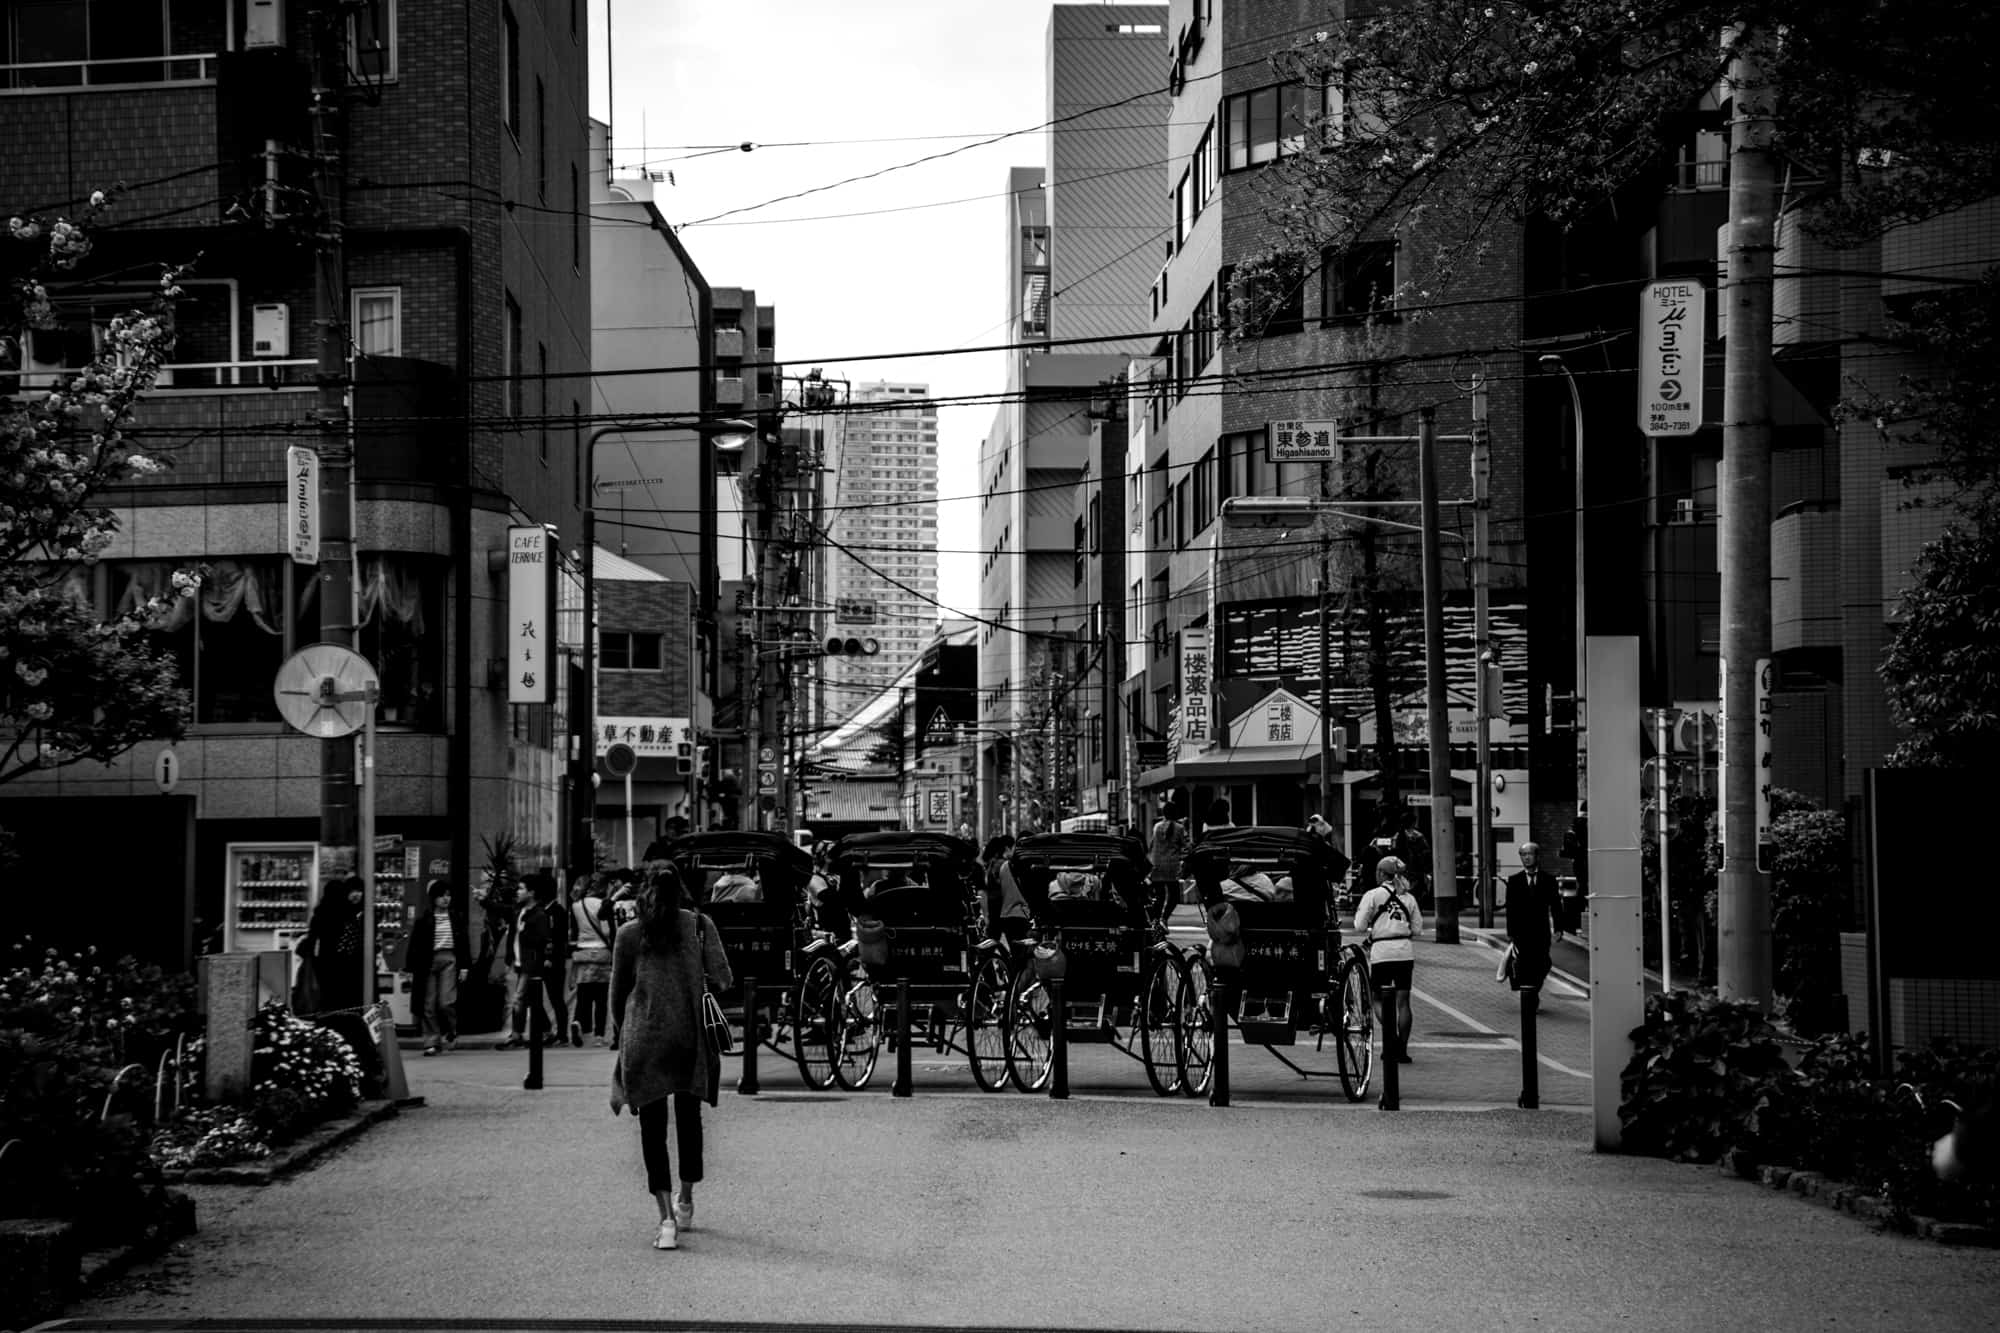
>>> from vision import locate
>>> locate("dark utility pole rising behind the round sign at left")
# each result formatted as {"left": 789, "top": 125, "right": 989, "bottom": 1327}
{"left": 308, "top": 0, "right": 362, "bottom": 880}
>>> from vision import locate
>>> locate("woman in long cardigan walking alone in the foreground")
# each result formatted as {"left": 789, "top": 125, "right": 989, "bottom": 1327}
{"left": 612, "top": 863, "right": 736, "bottom": 1249}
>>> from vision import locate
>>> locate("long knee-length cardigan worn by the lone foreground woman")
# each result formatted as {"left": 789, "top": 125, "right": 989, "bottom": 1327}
{"left": 612, "top": 909, "right": 736, "bottom": 1111}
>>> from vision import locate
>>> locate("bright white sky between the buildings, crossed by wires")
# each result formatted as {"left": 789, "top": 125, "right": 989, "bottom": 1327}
{"left": 588, "top": 0, "right": 1166, "bottom": 610}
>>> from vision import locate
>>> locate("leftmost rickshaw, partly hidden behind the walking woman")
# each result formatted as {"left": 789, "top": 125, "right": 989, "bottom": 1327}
{"left": 646, "top": 829, "right": 838, "bottom": 1091}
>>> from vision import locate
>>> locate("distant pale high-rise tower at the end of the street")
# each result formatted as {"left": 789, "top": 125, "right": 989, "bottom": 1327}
{"left": 820, "top": 382, "right": 938, "bottom": 704}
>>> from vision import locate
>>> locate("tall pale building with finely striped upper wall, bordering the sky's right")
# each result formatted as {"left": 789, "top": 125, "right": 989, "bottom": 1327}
{"left": 978, "top": 4, "right": 1172, "bottom": 833}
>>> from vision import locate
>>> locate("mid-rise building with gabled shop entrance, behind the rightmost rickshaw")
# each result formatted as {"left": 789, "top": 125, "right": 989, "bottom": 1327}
{"left": 1126, "top": 0, "right": 1534, "bottom": 860}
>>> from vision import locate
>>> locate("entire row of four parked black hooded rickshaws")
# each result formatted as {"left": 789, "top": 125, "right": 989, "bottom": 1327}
{"left": 648, "top": 827, "right": 1374, "bottom": 1101}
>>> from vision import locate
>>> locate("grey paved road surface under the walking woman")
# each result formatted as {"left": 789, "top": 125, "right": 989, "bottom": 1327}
{"left": 50, "top": 932, "right": 2000, "bottom": 1333}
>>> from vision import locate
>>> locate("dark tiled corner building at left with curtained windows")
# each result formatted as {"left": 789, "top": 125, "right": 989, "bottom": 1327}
{"left": 0, "top": 0, "right": 590, "bottom": 972}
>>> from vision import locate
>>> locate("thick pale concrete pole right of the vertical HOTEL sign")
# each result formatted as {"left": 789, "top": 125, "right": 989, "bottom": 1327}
{"left": 1716, "top": 30, "right": 1778, "bottom": 1009}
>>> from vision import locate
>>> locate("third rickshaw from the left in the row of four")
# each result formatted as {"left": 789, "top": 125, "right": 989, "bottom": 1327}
{"left": 1006, "top": 833, "right": 1190, "bottom": 1097}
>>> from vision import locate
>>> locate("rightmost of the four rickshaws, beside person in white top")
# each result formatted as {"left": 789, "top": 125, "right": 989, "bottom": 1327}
{"left": 1186, "top": 827, "right": 1374, "bottom": 1101}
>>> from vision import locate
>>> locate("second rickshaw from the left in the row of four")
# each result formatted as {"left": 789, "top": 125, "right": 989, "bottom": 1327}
{"left": 826, "top": 831, "right": 1012, "bottom": 1095}
